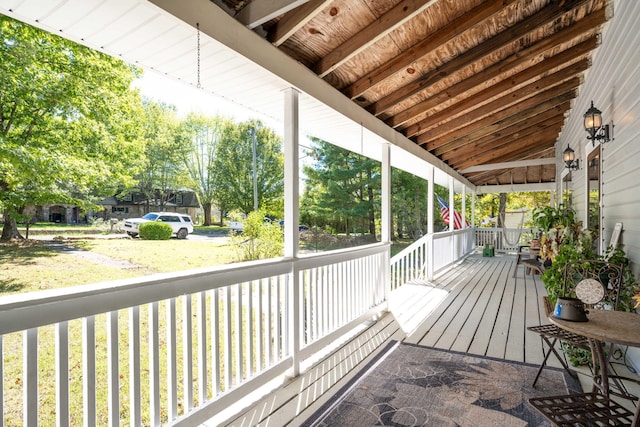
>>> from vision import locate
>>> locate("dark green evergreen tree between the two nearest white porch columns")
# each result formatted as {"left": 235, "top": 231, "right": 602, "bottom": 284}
{"left": 301, "top": 138, "right": 380, "bottom": 237}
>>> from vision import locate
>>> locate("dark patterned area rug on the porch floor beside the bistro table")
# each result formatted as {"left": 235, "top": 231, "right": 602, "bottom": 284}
{"left": 303, "top": 342, "right": 582, "bottom": 427}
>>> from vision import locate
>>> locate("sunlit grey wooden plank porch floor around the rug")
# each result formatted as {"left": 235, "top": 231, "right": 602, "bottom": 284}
{"left": 203, "top": 254, "right": 592, "bottom": 427}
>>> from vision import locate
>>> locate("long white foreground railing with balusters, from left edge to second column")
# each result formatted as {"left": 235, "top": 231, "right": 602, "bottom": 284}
{"left": 0, "top": 244, "right": 389, "bottom": 426}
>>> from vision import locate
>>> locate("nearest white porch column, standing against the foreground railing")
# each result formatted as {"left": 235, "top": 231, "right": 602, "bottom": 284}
{"left": 283, "top": 88, "right": 302, "bottom": 377}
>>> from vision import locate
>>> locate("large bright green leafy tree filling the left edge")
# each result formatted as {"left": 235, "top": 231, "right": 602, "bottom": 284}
{"left": 0, "top": 16, "right": 142, "bottom": 240}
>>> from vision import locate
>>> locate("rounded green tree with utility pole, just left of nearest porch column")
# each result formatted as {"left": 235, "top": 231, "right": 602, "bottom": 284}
{"left": 213, "top": 120, "right": 284, "bottom": 217}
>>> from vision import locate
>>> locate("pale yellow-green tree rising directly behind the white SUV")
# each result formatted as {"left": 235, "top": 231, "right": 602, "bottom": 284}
{"left": 136, "top": 99, "right": 188, "bottom": 212}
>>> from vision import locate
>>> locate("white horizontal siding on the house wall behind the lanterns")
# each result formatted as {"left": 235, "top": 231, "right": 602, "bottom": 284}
{"left": 556, "top": 0, "right": 640, "bottom": 367}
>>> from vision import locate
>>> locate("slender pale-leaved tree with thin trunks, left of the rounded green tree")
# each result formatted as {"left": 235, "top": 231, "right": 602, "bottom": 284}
{"left": 180, "top": 114, "right": 234, "bottom": 225}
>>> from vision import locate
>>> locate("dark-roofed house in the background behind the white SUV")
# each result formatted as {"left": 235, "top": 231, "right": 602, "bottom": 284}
{"left": 96, "top": 190, "right": 200, "bottom": 220}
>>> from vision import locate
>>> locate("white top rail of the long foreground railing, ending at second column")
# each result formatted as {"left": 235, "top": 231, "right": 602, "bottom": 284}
{"left": 0, "top": 243, "right": 389, "bottom": 335}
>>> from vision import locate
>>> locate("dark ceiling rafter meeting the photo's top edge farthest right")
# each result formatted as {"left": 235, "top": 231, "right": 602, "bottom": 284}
{"left": 368, "top": 0, "right": 585, "bottom": 115}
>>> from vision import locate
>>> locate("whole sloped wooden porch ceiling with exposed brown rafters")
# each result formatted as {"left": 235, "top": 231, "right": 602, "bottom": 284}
{"left": 212, "top": 0, "right": 611, "bottom": 185}
